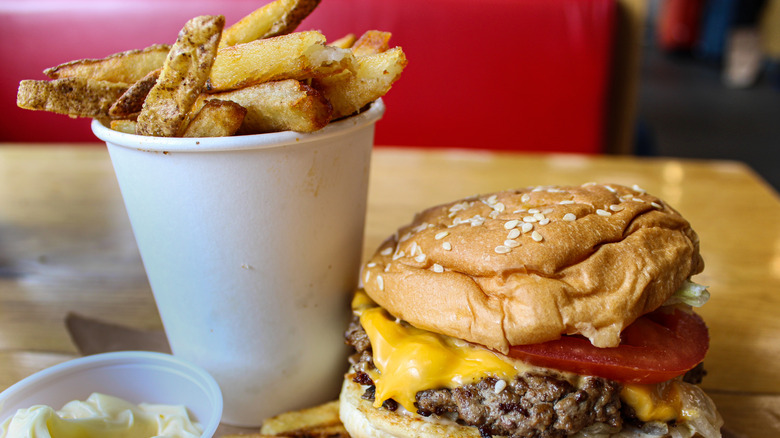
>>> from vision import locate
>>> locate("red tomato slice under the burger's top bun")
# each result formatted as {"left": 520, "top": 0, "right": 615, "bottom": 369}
{"left": 509, "top": 308, "right": 709, "bottom": 384}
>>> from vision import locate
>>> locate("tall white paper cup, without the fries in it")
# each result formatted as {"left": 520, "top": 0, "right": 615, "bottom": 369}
{"left": 92, "top": 100, "right": 384, "bottom": 427}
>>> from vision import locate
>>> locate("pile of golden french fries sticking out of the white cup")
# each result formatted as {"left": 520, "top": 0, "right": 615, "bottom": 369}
{"left": 17, "top": 0, "right": 407, "bottom": 137}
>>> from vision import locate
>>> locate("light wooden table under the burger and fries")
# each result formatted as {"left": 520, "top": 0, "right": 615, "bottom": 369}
{"left": 0, "top": 144, "right": 780, "bottom": 437}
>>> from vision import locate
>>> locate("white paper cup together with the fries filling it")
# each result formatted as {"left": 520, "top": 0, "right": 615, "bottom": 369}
{"left": 17, "top": 0, "right": 406, "bottom": 426}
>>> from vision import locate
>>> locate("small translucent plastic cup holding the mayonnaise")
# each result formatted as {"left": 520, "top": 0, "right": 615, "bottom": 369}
{"left": 0, "top": 351, "right": 222, "bottom": 438}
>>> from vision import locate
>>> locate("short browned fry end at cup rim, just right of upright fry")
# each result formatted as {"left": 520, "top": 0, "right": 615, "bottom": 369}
{"left": 184, "top": 99, "right": 246, "bottom": 137}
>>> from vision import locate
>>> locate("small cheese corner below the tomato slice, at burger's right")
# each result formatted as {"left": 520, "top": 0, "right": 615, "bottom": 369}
{"left": 620, "top": 380, "right": 685, "bottom": 422}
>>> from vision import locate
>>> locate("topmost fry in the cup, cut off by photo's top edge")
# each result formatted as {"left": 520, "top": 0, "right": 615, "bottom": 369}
{"left": 219, "top": 0, "right": 320, "bottom": 47}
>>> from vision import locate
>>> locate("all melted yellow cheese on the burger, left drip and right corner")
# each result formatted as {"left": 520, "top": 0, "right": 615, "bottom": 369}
{"left": 352, "top": 292, "right": 687, "bottom": 422}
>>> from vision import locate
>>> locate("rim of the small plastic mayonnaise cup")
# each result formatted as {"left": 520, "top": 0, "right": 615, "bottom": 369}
{"left": 0, "top": 351, "right": 223, "bottom": 438}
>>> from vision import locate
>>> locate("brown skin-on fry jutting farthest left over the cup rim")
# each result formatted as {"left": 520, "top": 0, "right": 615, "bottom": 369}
{"left": 16, "top": 78, "right": 128, "bottom": 118}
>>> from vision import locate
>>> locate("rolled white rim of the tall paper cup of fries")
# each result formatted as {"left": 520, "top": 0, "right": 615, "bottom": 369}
{"left": 92, "top": 98, "right": 385, "bottom": 152}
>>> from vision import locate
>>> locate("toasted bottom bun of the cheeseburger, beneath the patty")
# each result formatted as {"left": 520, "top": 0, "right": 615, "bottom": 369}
{"left": 339, "top": 372, "right": 723, "bottom": 438}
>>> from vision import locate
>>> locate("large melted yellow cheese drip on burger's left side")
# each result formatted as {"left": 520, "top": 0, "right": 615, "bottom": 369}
{"left": 360, "top": 307, "right": 517, "bottom": 412}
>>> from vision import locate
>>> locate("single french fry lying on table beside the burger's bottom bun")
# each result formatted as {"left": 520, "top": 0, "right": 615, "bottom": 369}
{"left": 221, "top": 400, "right": 349, "bottom": 438}
